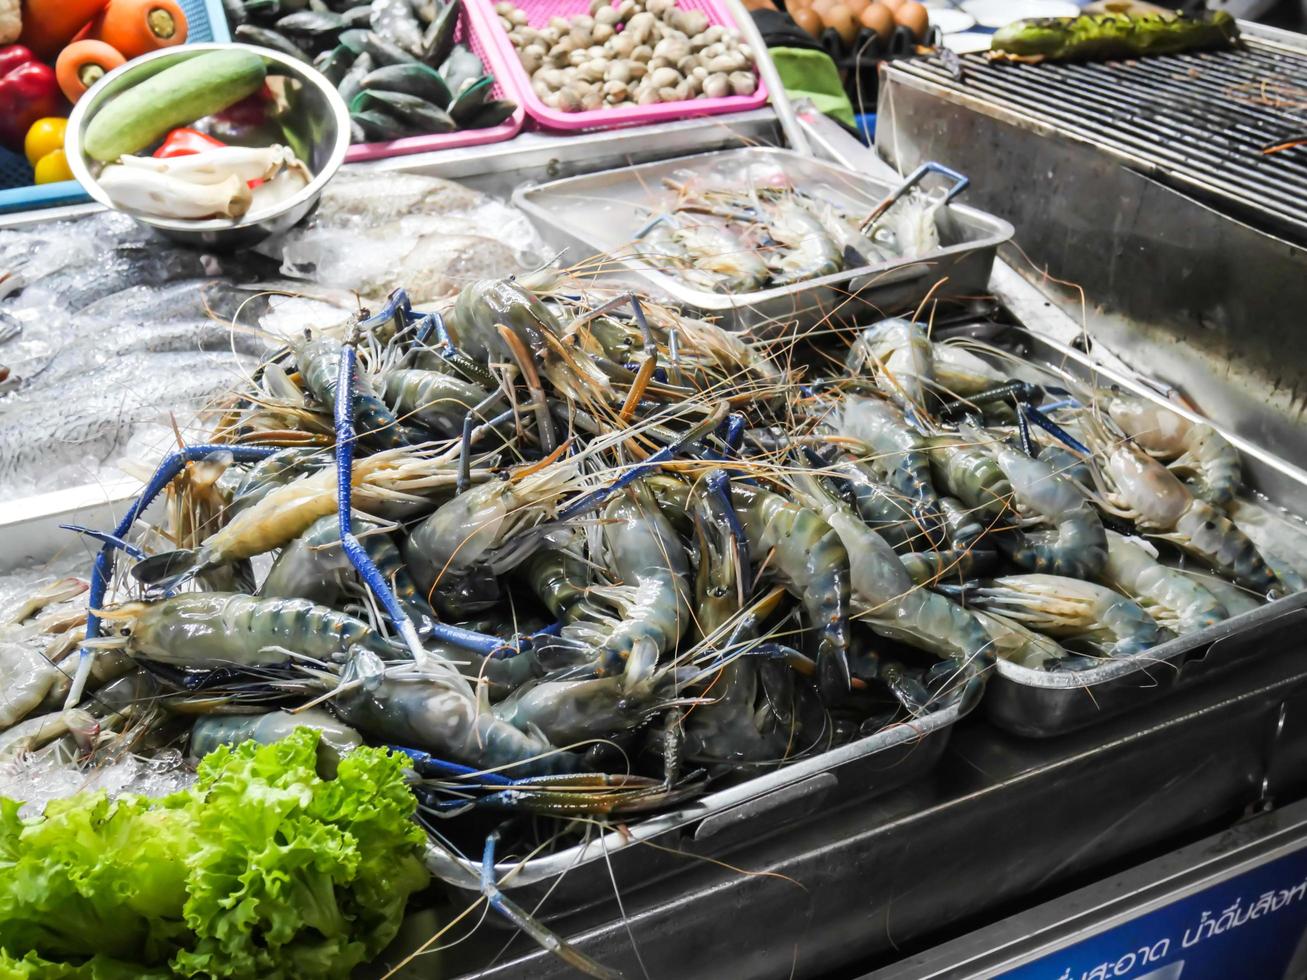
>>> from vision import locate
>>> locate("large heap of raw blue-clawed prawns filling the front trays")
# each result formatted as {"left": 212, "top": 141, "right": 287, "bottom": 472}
{"left": 10, "top": 269, "right": 1307, "bottom": 976}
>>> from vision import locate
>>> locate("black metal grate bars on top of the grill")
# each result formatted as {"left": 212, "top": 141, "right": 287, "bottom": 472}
{"left": 891, "top": 38, "right": 1307, "bottom": 238}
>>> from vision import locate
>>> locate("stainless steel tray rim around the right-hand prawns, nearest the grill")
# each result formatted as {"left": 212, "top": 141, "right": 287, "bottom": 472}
{"left": 953, "top": 324, "right": 1307, "bottom": 738}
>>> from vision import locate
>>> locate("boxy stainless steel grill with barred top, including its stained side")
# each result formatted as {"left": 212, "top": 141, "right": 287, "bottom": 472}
{"left": 877, "top": 25, "right": 1307, "bottom": 478}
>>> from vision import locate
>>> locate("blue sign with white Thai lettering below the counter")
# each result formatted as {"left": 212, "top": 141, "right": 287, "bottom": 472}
{"left": 1002, "top": 847, "right": 1307, "bottom": 980}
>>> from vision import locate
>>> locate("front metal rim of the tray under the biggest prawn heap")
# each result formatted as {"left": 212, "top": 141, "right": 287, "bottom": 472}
{"left": 429, "top": 704, "right": 965, "bottom": 921}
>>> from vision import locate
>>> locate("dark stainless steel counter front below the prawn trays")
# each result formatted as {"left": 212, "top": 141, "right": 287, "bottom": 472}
{"left": 392, "top": 616, "right": 1307, "bottom": 980}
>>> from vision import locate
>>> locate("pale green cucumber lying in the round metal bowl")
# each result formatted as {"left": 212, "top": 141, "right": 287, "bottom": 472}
{"left": 82, "top": 51, "right": 268, "bottom": 163}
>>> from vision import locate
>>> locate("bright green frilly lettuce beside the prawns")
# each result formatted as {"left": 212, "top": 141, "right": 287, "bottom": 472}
{"left": 0, "top": 729, "right": 427, "bottom": 980}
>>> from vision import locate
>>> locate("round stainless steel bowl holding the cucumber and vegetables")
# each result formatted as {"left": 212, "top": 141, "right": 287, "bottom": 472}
{"left": 64, "top": 44, "right": 349, "bottom": 248}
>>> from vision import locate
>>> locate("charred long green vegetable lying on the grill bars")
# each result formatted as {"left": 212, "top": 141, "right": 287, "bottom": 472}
{"left": 989, "top": 10, "right": 1239, "bottom": 63}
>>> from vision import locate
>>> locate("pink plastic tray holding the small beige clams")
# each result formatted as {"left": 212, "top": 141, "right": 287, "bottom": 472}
{"left": 464, "top": 0, "right": 767, "bottom": 131}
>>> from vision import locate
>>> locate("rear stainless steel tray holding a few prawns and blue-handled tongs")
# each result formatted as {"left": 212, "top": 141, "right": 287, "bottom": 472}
{"left": 512, "top": 146, "right": 1012, "bottom": 329}
